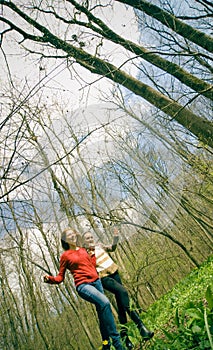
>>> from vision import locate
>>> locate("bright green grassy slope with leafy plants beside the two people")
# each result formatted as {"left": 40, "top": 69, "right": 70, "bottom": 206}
{"left": 129, "top": 257, "right": 213, "bottom": 350}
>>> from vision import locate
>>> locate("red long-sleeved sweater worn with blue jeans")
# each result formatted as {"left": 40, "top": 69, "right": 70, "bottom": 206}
{"left": 48, "top": 248, "right": 99, "bottom": 287}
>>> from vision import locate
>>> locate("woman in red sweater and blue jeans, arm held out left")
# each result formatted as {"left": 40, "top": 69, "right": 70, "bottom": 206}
{"left": 44, "top": 227, "right": 124, "bottom": 350}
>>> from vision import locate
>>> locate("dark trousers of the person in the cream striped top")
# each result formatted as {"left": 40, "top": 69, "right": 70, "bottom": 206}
{"left": 101, "top": 271, "right": 131, "bottom": 324}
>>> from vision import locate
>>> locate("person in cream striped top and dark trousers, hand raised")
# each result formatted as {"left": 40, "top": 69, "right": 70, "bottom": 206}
{"left": 82, "top": 228, "right": 154, "bottom": 350}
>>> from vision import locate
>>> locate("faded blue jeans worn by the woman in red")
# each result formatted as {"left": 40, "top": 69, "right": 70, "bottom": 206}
{"left": 76, "top": 278, "right": 123, "bottom": 350}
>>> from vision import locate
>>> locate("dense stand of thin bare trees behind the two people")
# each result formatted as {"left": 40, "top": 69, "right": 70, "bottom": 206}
{"left": 0, "top": 93, "right": 212, "bottom": 349}
